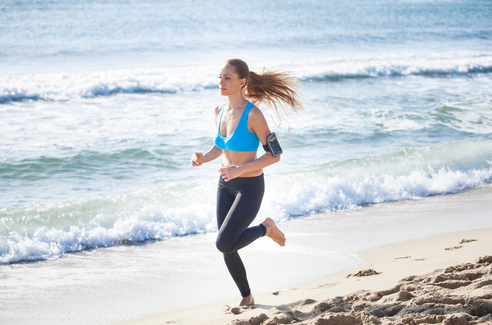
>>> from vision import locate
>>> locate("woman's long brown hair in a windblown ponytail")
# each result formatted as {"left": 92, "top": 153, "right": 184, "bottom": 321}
{"left": 226, "top": 59, "right": 303, "bottom": 115}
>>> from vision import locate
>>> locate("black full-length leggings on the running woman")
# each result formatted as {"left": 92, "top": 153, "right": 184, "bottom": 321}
{"left": 216, "top": 174, "right": 266, "bottom": 297}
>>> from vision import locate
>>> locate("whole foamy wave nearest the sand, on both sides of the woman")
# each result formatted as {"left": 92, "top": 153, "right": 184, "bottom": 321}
{"left": 0, "top": 140, "right": 492, "bottom": 264}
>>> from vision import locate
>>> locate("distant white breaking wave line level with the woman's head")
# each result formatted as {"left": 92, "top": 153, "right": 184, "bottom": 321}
{"left": 0, "top": 52, "right": 492, "bottom": 104}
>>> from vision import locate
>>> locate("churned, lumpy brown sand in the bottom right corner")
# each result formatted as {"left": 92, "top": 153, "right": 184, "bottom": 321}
{"left": 229, "top": 256, "right": 492, "bottom": 325}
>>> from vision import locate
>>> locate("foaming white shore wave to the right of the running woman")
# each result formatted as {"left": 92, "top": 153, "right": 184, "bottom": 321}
{"left": 267, "top": 140, "right": 492, "bottom": 219}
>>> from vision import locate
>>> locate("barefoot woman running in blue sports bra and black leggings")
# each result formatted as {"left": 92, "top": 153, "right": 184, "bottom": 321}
{"left": 191, "top": 59, "right": 302, "bottom": 306}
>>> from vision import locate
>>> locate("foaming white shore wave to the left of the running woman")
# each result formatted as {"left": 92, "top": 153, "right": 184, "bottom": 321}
{"left": 0, "top": 185, "right": 219, "bottom": 264}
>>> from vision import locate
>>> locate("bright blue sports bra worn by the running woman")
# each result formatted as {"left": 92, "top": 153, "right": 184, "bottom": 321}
{"left": 214, "top": 103, "right": 260, "bottom": 151}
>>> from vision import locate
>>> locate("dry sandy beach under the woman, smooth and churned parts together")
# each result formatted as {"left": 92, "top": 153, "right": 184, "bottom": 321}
{"left": 117, "top": 187, "right": 492, "bottom": 325}
